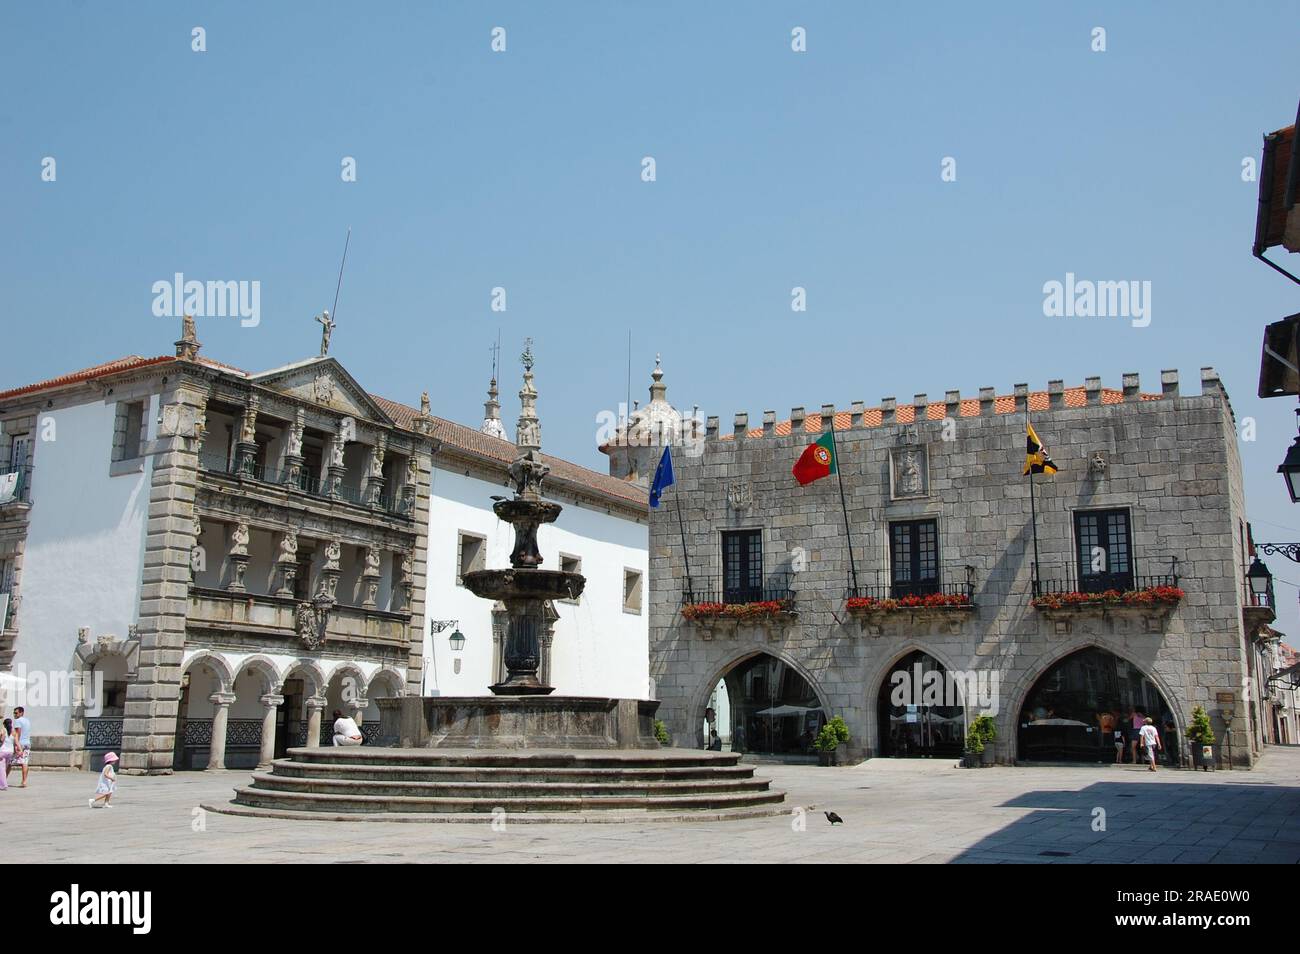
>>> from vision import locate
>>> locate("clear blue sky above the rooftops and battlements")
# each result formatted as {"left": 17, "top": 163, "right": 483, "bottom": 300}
{"left": 0, "top": 3, "right": 1300, "bottom": 630}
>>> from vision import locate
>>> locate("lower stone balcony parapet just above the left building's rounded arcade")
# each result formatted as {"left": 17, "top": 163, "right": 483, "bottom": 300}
{"left": 187, "top": 586, "right": 411, "bottom": 650}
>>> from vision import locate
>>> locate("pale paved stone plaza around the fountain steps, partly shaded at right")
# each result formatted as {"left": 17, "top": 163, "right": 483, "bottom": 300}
{"left": 10, "top": 747, "right": 1300, "bottom": 864}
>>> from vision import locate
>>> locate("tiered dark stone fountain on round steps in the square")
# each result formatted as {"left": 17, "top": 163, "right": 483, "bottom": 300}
{"left": 224, "top": 348, "right": 785, "bottom": 821}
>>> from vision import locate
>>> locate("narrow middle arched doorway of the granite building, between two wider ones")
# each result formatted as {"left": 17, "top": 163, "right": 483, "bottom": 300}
{"left": 878, "top": 650, "right": 966, "bottom": 759}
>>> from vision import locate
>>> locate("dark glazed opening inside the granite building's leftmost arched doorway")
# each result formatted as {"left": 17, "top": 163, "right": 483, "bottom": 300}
{"left": 705, "top": 652, "right": 827, "bottom": 755}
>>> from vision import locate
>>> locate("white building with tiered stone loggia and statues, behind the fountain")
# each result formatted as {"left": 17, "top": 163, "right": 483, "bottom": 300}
{"left": 0, "top": 321, "right": 649, "bottom": 772}
